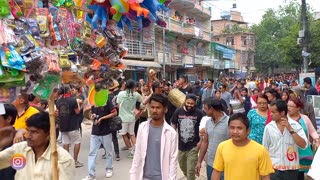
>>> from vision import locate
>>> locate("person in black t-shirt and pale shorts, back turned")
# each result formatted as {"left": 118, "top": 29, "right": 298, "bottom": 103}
{"left": 56, "top": 86, "right": 83, "bottom": 168}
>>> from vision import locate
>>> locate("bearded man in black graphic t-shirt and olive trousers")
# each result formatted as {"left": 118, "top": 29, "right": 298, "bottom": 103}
{"left": 171, "top": 94, "right": 203, "bottom": 180}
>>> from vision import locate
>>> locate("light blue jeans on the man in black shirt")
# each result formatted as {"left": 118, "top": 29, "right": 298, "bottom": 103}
{"left": 88, "top": 133, "right": 113, "bottom": 177}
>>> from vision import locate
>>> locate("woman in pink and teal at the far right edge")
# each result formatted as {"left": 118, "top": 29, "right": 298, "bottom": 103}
{"left": 288, "top": 98, "right": 319, "bottom": 180}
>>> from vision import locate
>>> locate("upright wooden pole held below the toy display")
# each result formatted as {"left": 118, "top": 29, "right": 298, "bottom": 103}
{"left": 48, "top": 96, "right": 59, "bottom": 180}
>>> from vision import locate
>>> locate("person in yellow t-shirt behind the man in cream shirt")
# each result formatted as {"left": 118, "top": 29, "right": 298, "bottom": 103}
{"left": 12, "top": 91, "right": 39, "bottom": 130}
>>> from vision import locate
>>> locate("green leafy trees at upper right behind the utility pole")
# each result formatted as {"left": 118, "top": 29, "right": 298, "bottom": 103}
{"left": 252, "top": 0, "right": 320, "bottom": 72}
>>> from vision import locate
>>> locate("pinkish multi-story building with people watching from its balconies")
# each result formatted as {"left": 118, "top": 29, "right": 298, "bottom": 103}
{"left": 155, "top": 0, "right": 213, "bottom": 81}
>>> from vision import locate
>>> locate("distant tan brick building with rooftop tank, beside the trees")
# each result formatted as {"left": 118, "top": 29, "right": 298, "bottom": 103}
{"left": 211, "top": 11, "right": 255, "bottom": 74}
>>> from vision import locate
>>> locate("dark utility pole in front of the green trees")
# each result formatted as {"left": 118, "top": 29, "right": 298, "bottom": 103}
{"left": 301, "top": 0, "right": 309, "bottom": 73}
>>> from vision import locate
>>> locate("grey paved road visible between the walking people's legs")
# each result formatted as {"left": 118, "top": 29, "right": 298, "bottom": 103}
{"left": 67, "top": 121, "right": 206, "bottom": 180}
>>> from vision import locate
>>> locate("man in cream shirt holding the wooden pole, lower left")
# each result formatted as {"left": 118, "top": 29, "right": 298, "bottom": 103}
{"left": 0, "top": 112, "right": 75, "bottom": 180}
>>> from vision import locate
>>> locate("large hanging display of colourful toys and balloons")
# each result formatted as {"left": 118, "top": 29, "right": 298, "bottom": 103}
{"left": 0, "top": 0, "right": 171, "bottom": 106}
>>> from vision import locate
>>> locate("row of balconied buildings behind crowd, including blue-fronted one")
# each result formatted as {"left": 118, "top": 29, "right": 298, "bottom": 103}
{"left": 124, "top": 0, "right": 238, "bottom": 81}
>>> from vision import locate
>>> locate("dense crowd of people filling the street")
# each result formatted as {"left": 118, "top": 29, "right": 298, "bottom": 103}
{"left": 0, "top": 75, "right": 320, "bottom": 180}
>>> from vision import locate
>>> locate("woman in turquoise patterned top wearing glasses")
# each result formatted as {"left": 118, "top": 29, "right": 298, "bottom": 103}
{"left": 247, "top": 93, "right": 271, "bottom": 144}
